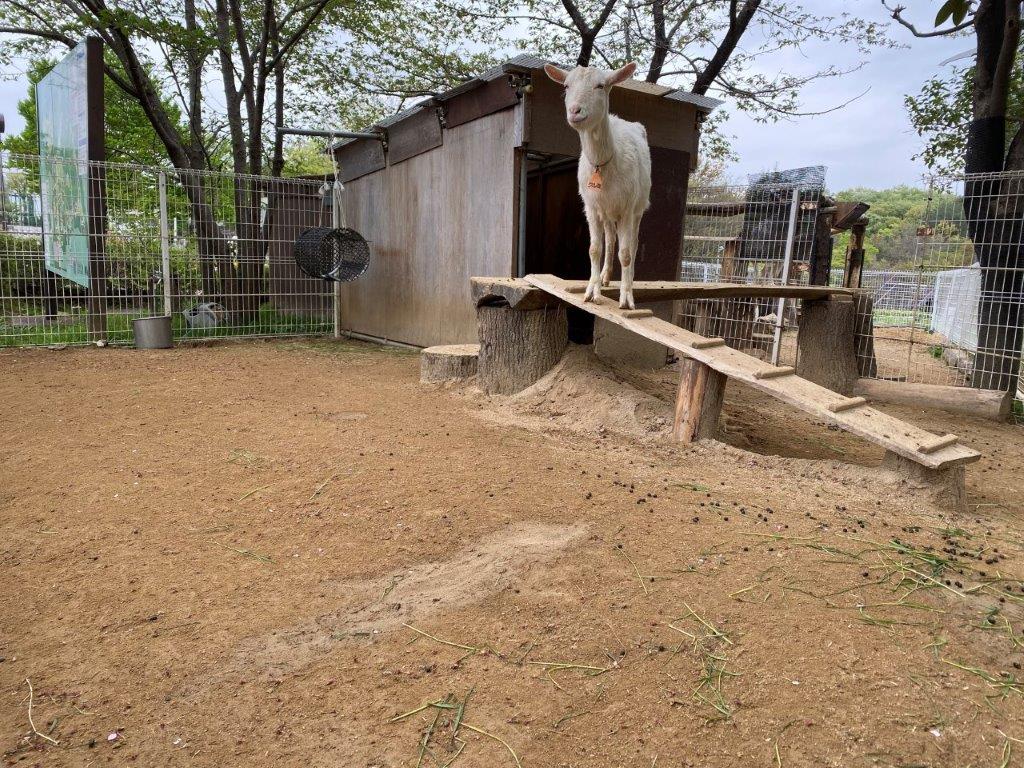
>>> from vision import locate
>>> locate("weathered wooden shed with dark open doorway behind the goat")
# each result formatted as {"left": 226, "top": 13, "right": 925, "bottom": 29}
{"left": 333, "top": 55, "right": 719, "bottom": 346}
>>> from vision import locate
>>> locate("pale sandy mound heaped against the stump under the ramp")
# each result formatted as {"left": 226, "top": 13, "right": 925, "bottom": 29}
{"left": 468, "top": 344, "right": 672, "bottom": 439}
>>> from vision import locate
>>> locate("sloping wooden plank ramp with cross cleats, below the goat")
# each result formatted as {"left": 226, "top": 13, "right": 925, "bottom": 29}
{"left": 524, "top": 274, "right": 981, "bottom": 469}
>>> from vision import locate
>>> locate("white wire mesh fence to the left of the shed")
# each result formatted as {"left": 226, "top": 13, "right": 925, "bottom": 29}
{"left": 0, "top": 155, "right": 334, "bottom": 346}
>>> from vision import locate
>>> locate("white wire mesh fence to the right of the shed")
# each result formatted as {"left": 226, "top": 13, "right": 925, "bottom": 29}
{"left": 681, "top": 172, "right": 1024, "bottom": 399}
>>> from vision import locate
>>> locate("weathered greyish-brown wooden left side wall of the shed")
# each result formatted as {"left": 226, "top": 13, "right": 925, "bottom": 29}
{"left": 341, "top": 110, "right": 516, "bottom": 346}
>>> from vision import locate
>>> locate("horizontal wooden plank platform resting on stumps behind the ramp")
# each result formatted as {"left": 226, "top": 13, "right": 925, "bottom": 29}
{"left": 470, "top": 275, "right": 855, "bottom": 309}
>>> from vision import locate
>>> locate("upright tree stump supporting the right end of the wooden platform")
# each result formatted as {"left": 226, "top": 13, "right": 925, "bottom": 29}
{"left": 797, "top": 296, "right": 857, "bottom": 395}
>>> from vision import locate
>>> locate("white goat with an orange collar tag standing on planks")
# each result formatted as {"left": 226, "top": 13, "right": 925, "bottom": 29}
{"left": 544, "top": 61, "right": 650, "bottom": 309}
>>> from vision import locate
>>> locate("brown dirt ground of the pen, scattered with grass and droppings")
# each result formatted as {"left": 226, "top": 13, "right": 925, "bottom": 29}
{"left": 0, "top": 342, "right": 1024, "bottom": 768}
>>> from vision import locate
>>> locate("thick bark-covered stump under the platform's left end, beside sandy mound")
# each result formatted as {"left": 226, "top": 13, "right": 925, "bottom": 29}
{"left": 476, "top": 304, "right": 568, "bottom": 394}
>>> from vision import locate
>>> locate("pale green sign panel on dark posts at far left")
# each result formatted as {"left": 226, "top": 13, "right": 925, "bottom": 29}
{"left": 36, "top": 42, "right": 89, "bottom": 288}
